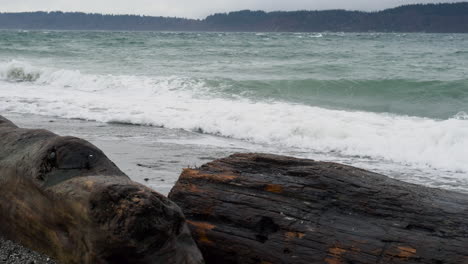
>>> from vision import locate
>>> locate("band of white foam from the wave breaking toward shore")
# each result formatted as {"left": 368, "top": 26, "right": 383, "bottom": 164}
{"left": 0, "top": 62, "right": 468, "bottom": 172}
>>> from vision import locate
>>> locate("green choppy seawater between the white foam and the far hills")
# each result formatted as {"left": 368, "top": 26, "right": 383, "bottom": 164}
{"left": 0, "top": 31, "right": 468, "bottom": 120}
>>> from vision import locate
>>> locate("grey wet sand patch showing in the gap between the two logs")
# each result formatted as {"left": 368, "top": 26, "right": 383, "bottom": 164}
{"left": 4, "top": 114, "right": 261, "bottom": 195}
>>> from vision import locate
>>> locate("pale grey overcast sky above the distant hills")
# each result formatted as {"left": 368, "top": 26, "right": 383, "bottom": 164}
{"left": 0, "top": 0, "right": 460, "bottom": 18}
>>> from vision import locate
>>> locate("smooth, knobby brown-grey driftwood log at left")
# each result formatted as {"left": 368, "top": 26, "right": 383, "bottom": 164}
{"left": 0, "top": 116, "right": 203, "bottom": 264}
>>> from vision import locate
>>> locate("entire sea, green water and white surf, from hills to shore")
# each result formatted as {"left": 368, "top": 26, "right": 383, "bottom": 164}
{"left": 0, "top": 31, "right": 468, "bottom": 192}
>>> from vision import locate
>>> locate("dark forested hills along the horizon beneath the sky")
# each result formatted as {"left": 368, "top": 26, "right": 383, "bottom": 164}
{"left": 0, "top": 2, "right": 468, "bottom": 33}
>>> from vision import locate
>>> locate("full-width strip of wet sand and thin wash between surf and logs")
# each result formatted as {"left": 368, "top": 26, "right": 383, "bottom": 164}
{"left": 2, "top": 112, "right": 468, "bottom": 195}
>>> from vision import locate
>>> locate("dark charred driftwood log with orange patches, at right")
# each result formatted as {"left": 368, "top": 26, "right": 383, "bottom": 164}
{"left": 169, "top": 154, "right": 468, "bottom": 264}
